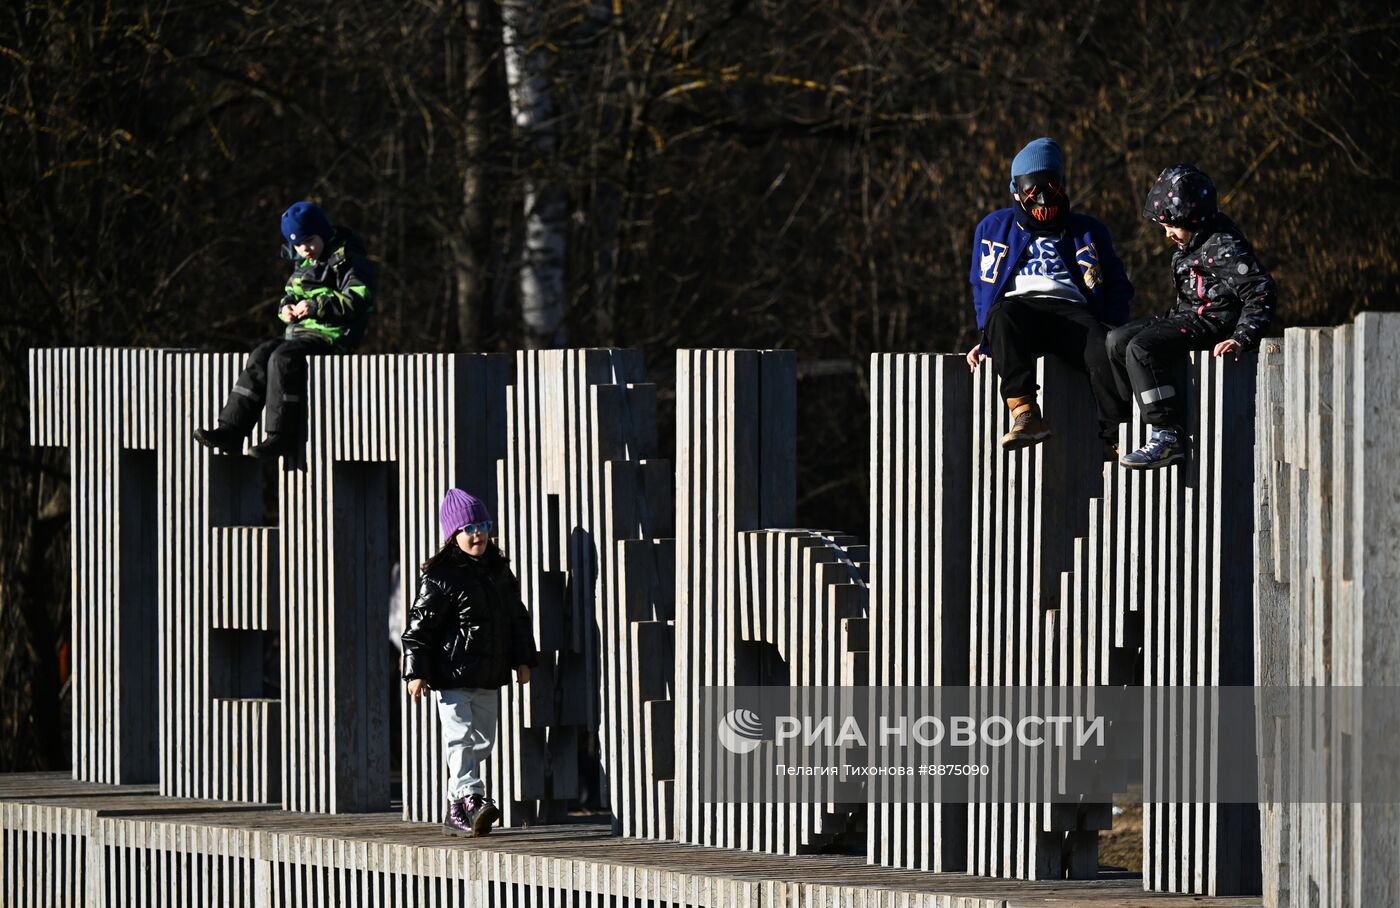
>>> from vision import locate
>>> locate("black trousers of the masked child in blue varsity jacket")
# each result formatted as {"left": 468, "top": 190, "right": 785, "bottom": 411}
{"left": 987, "top": 297, "right": 1133, "bottom": 441}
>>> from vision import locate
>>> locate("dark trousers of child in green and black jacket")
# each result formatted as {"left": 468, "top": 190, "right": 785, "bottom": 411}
{"left": 218, "top": 336, "right": 335, "bottom": 435}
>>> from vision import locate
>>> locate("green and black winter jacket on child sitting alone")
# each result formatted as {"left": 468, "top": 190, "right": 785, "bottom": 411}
{"left": 277, "top": 227, "right": 374, "bottom": 350}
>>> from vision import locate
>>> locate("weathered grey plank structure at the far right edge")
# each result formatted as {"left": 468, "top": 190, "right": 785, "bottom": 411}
{"left": 1254, "top": 312, "right": 1400, "bottom": 908}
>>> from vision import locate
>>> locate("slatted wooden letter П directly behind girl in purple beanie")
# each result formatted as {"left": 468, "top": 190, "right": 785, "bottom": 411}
{"left": 289, "top": 355, "right": 510, "bottom": 816}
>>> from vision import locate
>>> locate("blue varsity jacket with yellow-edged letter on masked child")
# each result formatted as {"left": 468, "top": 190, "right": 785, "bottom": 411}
{"left": 967, "top": 208, "right": 1133, "bottom": 339}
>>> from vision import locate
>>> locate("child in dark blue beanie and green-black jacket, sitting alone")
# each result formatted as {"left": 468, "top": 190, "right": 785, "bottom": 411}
{"left": 195, "top": 201, "right": 374, "bottom": 457}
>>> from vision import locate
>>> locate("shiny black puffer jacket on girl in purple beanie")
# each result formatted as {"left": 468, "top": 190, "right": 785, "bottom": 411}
{"left": 403, "top": 543, "right": 536, "bottom": 690}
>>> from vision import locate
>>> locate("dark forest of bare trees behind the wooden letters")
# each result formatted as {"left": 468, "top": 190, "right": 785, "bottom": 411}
{"left": 0, "top": 0, "right": 1400, "bottom": 772}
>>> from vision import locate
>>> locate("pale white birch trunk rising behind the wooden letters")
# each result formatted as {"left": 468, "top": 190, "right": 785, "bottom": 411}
{"left": 501, "top": 0, "right": 568, "bottom": 348}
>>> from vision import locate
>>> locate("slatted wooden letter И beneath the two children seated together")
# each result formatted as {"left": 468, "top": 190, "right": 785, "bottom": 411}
{"left": 963, "top": 354, "right": 1259, "bottom": 894}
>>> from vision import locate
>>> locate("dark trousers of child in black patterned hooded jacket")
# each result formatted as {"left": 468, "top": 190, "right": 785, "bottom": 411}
{"left": 1109, "top": 312, "right": 1235, "bottom": 428}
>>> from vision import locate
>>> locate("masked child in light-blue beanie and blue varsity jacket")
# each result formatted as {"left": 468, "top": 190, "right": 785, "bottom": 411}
{"left": 967, "top": 139, "right": 1133, "bottom": 460}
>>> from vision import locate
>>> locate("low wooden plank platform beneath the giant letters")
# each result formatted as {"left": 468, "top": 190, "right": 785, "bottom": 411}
{"left": 0, "top": 774, "right": 1261, "bottom": 908}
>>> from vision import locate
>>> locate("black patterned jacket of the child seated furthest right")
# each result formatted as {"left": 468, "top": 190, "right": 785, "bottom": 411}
{"left": 1172, "top": 214, "right": 1278, "bottom": 350}
